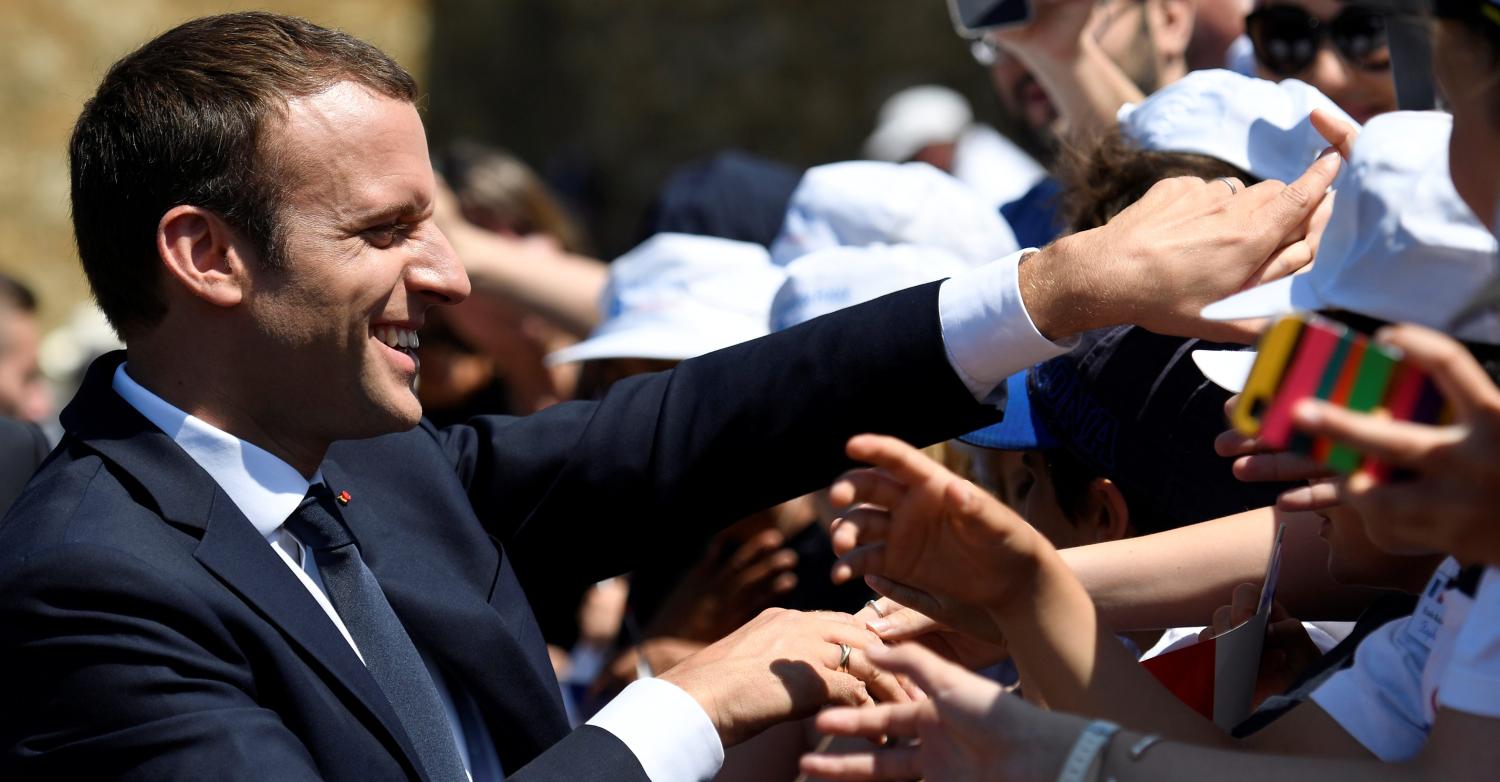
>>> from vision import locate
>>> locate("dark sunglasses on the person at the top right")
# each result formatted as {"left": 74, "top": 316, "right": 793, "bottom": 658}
{"left": 1245, "top": 6, "right": 1391, "bottom": 77}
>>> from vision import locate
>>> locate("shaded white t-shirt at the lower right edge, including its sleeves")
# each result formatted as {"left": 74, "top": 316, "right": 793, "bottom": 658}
{"left": 1313, "top": 558, "right": 1500, "bottom": 762}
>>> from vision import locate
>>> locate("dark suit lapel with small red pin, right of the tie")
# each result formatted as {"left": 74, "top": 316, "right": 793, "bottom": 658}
{"left": 323, "top": 459, "right": 569, "bottom": 768}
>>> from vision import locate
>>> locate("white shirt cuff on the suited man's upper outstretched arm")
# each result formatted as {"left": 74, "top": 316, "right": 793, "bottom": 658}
{"left": 938, "top": 249, "right": 1077, "bottom": 402}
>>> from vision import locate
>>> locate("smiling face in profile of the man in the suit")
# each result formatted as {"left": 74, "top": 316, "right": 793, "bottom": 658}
{"left": 242, "top": 83, "right": 470, "bottom": 444}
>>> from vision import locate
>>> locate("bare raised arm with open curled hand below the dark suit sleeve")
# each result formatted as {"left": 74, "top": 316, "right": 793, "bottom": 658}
{"left": 833, "top": 435, "right": 1364, "bottom": 753}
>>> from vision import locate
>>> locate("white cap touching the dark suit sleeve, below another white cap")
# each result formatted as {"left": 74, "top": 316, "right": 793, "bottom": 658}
{"left": 771, "top": 245, "right": 969, "bottom": 332}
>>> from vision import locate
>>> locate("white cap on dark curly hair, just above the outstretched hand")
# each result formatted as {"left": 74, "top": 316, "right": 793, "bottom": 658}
{"left": 1118, "top": 71, "right": 1359, "bottom": 182}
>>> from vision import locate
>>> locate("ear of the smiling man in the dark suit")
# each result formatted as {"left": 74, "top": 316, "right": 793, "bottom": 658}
{"left": 156, "top": 204, "right": 249, "bottom": 308}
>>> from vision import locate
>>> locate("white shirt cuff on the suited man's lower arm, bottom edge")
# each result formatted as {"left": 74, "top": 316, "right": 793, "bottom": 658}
{"left": 588, "top": 678, "right": 725, "bottom": 782}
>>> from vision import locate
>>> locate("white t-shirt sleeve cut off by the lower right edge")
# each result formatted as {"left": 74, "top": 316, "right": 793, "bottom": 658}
{"left": 1437, "top": 567, "right": 1500, "bottom": 717}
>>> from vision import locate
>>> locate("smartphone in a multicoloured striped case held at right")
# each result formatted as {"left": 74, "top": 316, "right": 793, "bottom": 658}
{"left": 1230, "top": 312, "right": 1449, "bottom": 479}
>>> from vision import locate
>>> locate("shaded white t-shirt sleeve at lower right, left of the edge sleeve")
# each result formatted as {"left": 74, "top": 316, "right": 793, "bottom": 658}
{"left": 1313, "top": 617, "right": 1428, "bottom": 762}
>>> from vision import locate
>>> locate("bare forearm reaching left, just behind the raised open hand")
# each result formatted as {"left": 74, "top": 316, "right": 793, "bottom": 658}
{"left": 1061, "top": 507, "right": 1376, "bottom": 630}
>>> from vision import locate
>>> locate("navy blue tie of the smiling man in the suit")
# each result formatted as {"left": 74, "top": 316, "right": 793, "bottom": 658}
{"left": 287, "top": 483, "right": 468, "bottom": 782}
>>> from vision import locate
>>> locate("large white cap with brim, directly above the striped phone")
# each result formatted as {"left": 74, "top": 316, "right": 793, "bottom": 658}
{"left": 1193, "top": 111, "right": 1500, "bottom": 390}
